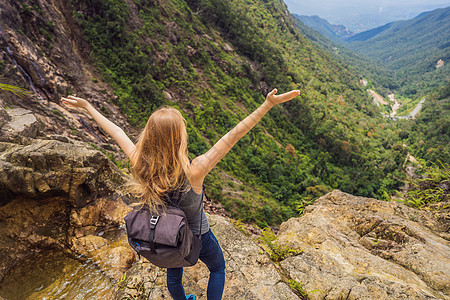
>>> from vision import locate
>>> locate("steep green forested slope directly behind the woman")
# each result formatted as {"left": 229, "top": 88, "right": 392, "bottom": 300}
{"left": 1, "top": 0, "right": 406, "bottom": 225}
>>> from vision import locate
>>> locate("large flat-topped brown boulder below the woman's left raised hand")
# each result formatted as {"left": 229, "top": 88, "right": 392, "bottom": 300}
{"left": 0, "top": 140, "right": 125, "bottom": 208}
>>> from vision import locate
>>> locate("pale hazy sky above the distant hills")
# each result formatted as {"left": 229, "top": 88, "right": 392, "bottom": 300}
{"left": 284, "top": 0, "right": 450, "bottom": 31}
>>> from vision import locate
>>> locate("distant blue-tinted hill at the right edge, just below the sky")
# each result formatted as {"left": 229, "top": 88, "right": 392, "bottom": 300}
{"left": 348, "top": 7, "right": 450, "bottom": 70}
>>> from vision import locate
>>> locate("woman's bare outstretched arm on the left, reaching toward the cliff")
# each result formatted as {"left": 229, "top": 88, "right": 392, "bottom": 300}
{"left": 61, "top": 96, "right": 136, "bottom": 159}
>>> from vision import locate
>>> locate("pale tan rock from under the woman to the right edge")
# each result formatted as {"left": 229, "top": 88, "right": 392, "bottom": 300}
{"left": 116, "top": 190, "right": 450, "bottom": 299}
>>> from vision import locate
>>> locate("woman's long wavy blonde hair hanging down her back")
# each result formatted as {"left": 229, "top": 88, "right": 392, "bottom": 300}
{"left": 126, "top": 106, "right": 189, "bottom": 210}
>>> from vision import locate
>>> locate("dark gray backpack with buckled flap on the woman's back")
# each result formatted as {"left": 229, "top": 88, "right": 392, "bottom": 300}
{"left": 124, "top": 191, "right": 202, "bottom": 268}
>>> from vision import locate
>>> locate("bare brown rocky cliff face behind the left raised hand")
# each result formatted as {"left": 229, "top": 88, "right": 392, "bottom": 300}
{"left": 0, "top": 0, "right": 134, "bottom": 150}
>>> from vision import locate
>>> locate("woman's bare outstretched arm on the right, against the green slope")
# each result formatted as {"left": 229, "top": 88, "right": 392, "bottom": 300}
{"left": 189, "top": 89, "right": 300, "bottom": 192}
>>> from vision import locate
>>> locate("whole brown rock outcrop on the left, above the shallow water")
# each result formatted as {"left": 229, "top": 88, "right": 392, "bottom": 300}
{"left": 0, "top": 136, "right": 135, "bottom": 282}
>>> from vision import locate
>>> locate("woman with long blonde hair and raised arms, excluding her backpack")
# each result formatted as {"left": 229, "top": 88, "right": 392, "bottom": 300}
{"left": 61, "top": 89, "right": 300, "bottom": 300}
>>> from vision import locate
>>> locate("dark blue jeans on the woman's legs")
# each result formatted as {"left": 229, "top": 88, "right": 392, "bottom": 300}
{"left": 167, "top": 230, "right": 225, "bottom": 300}
